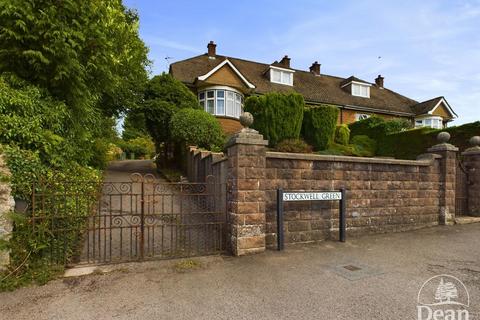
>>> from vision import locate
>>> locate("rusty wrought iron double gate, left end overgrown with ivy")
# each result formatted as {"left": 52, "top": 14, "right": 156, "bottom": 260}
{"left": 31, "top": 173, "right": 226, "bottom": 264}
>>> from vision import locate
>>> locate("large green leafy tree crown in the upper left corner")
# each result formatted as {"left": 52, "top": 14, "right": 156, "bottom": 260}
{"left": 0, "top": 0, "right": 149, "bottom": 120}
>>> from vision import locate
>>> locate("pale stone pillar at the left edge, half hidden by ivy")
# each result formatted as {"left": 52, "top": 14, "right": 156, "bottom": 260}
{"left": 0, "top": 155, "right": 15, "bottom": 271}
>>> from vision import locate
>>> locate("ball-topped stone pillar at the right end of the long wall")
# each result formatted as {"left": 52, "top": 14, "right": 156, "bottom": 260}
{"left": 428, "top": 132, "right": 458, "bottom": 225}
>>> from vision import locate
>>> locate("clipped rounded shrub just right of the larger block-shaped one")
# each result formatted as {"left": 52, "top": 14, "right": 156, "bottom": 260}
{"left": 302, "top": 105, "right": 339, "bottom": 150}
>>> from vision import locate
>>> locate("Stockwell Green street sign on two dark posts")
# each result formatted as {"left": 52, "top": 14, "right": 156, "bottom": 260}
{"left": 277, "top": 188, "right": 347, "bottom": 251}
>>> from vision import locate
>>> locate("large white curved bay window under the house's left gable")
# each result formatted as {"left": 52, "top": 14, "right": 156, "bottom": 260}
{"left": 197, "top": 86, "right": 243, "bottom": 119}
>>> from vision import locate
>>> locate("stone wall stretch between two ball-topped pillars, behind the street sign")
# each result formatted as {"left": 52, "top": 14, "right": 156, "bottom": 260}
{"left": 264, "top": 152, "right": 441, "bottom": 247}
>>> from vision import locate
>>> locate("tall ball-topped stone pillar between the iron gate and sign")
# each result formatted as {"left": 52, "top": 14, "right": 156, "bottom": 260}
{"left": 227, "top": 113, "right": 268, "bottom": 256}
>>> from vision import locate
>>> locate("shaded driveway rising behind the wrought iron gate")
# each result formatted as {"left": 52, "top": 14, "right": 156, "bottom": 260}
{"left": 79, "top": 160, "right": 225, "bottom": 264}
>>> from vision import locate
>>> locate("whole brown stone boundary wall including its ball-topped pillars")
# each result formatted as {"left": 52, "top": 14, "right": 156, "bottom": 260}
{"left": 187, "top": 127, "right": 462, "bottom": 255}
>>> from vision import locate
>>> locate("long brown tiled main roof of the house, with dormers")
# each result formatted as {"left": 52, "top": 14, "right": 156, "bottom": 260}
{"left": 170, "top": 54, "right": 450, "bottom": 115}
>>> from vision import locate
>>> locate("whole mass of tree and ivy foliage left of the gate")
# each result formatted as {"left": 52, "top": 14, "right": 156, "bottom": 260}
{"left": 0, "top": 0, "right": 149, "bottom": 290}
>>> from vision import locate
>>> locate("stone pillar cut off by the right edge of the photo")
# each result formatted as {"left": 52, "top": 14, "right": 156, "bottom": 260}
{"left": 462, "top": 136, "right": 480, "bottom": 217}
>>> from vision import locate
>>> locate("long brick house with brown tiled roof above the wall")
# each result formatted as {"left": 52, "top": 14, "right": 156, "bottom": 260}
{"left": 169, "top": 41, "right": 457, "bottom": 133}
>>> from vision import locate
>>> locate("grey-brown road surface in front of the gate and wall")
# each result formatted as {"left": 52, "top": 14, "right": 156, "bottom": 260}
{"left": 0, "top": 224, "right": 480, "bottom": 320}
